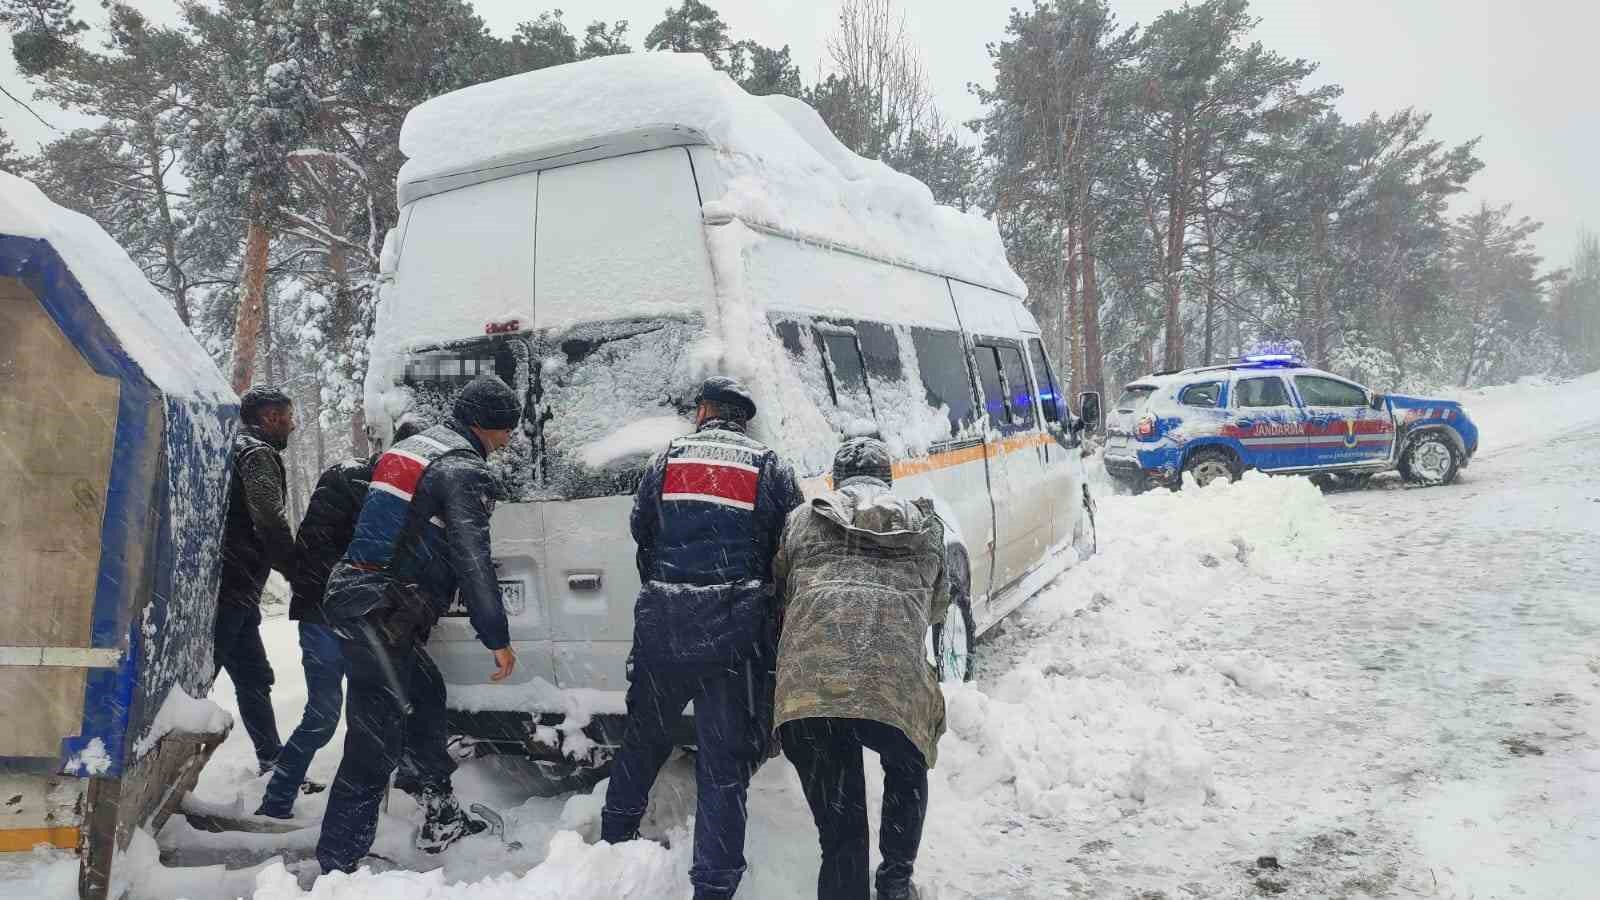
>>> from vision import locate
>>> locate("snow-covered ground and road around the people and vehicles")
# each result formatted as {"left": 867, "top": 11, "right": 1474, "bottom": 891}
{"left": 0, "top": 368, "right": 1600, "bottom": 900}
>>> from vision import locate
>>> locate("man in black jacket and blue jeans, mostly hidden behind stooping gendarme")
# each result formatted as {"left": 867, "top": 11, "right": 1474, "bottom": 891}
{"left": 256, "top": 421, "right": 421, "bottom": 818}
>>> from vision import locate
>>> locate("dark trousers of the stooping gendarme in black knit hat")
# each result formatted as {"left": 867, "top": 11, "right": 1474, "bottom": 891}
{"left": 317, "top": 625, "right": 456, "bottom": 871}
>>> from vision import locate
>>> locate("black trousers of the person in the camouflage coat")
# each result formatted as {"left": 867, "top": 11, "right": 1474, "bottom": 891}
{"left": 778, "top": 719, "right": 928, "bottom": 900}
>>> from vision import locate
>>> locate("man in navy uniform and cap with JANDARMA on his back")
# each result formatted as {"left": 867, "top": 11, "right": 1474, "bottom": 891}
{"left": 600, "top": 376, "right": 803, "bottom": 900}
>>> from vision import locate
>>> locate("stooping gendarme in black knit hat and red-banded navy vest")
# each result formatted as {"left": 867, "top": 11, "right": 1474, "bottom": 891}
{"left": 317, "top": 375, "right": 522, "bottom": 871}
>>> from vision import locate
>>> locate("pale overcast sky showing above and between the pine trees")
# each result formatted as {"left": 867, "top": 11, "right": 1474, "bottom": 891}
{"left": 0, "top": 0, "right": 1600, "bottom": 266}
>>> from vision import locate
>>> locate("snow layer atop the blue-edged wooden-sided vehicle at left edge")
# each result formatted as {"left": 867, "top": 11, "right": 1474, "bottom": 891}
{"left": 0, "top": 171, "right": 237, "bottom": 404}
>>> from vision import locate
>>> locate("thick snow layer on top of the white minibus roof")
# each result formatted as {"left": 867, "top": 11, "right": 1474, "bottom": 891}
{"left": 400, "top": 53, "right": 1027, "bottom": 296}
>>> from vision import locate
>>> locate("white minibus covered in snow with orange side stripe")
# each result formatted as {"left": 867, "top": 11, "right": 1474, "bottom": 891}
{"left": 366, "top": 53, "right": 1093, "bottom": 778}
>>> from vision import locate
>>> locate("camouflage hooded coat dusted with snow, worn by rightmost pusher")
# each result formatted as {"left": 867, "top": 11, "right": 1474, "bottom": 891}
{"left": 773, "top": 477, "right": 950, "bottom": 767}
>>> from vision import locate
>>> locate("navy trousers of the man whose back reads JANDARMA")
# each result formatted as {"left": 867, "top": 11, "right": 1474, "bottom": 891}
{"left": 600, "top": 665, "right": 771, "bottom": 898}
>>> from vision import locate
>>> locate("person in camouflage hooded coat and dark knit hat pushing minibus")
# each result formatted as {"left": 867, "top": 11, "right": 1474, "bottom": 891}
{"left": 773, "top": 437, "right": 950, "bottom": 900}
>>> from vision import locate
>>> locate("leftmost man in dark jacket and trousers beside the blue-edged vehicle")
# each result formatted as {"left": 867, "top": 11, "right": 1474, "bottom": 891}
{"left": 213, "top": 386, "right": 294, "bottom": 772}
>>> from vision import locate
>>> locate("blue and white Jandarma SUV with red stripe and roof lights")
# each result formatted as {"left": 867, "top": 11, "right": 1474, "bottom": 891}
{"left": 1106, "top": 354, "right": 1478, "bottom": 490}
